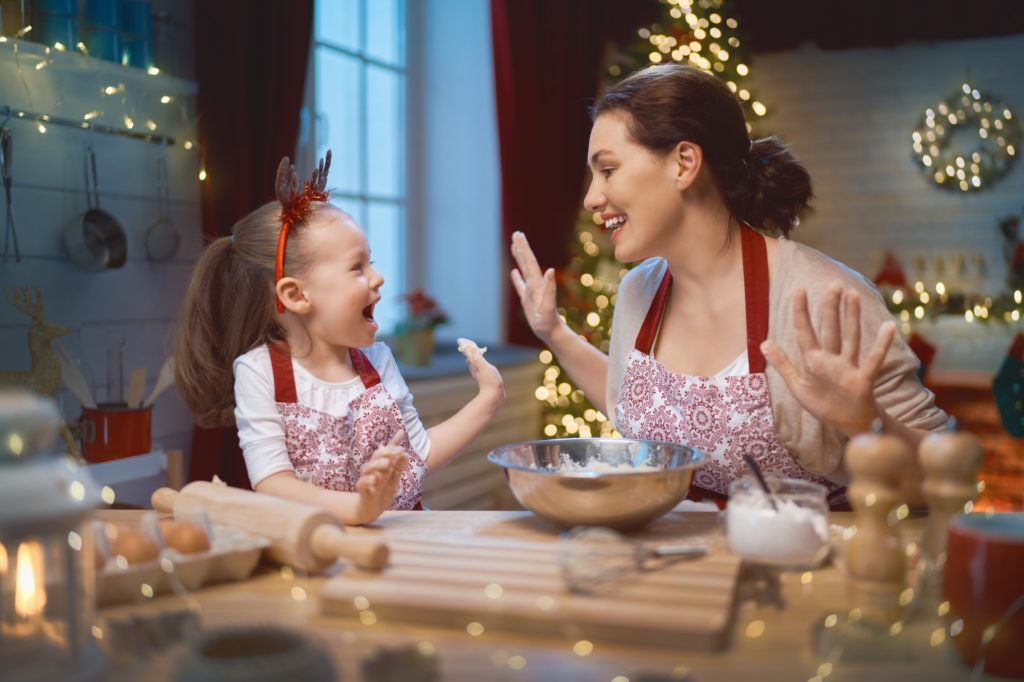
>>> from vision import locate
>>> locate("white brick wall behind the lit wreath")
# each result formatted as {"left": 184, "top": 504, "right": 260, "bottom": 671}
{"left": 751, "top": 36, "right": 1024, "bottom": 293}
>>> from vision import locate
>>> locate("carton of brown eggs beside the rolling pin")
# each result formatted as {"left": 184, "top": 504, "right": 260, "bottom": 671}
{"left": 96, "top": 524, "right": 270, "bottom": 606}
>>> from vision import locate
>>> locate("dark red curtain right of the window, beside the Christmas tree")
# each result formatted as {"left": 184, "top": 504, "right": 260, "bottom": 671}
{"left": 490, "top": 0, "right": 658, "bottom": 345}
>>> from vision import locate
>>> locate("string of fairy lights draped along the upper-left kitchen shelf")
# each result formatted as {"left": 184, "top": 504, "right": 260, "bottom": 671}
{"left": 0, "top": 26, "right": 208, "bottom": 181}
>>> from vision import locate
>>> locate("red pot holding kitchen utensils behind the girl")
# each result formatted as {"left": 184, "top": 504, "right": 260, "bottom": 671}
{"left": 81, "top": 404, "right": 153, "bottom": 463}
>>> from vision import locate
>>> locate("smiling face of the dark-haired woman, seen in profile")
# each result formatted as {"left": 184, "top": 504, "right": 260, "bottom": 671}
{"left": 584, "top": 111, "right": 682, "bottom": 262}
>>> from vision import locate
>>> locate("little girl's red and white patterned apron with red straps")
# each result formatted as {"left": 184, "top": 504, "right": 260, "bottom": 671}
{"left": 267, "top": 342, "right": 427, "bottom": 510}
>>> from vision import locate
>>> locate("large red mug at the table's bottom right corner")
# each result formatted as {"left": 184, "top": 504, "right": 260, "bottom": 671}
{"left": 943, "top": 513, "right": 1024, "bottom": 678}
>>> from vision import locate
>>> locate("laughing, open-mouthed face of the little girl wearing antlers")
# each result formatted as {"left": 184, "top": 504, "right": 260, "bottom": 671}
{"left": 302, "top": 208, "right": 384, "bottom": 348}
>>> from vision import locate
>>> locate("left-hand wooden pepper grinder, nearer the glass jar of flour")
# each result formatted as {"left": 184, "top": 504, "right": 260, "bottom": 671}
{"left": 846, "top": 420, "right": 911, "bottom": 625}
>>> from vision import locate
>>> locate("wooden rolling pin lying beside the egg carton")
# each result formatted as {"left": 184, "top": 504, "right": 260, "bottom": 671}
{"left": 151, "top": 481, "right": 388, "bottom": 572}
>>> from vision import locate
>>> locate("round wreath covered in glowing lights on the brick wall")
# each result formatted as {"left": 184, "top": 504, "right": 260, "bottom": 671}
{"left": 911, "top": 83, "right": 1021, "bottom": 193}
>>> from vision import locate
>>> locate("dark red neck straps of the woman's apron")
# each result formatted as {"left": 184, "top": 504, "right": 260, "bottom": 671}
{"left": 636, "top": 225, "right": 769, "bottom": 374}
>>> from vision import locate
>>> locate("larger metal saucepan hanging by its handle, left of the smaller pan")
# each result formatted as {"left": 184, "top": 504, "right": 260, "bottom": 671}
{"left": 65, "top": 144, "right": 128, "bottom": 270}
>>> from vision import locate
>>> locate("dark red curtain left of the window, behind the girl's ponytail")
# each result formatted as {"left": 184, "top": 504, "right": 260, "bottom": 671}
{"left": 188, "top": 0, "right": 313, "bottom": 487}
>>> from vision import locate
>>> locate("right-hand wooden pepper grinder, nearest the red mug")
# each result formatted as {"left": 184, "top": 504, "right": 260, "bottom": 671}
{"left": 919, "top": 419, "right": 985, "bottom": 572}
